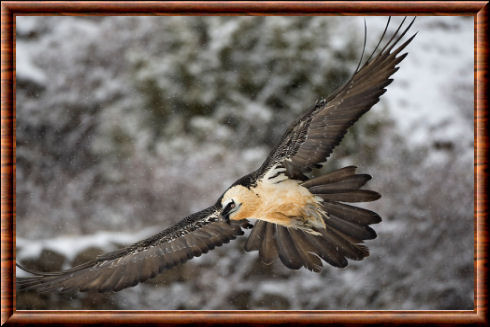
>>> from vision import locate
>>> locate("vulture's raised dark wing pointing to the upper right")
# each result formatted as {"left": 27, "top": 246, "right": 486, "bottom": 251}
{"left": 259, "top": 19, "right": 415, "bottom": 179}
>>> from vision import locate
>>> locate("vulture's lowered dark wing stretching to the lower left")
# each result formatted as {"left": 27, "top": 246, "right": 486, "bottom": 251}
{"left": 16, "top": 206, "right": 248, "bottom": 292}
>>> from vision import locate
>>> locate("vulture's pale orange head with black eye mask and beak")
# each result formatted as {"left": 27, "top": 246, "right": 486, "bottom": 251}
{"left": 220, "top": 185, "right": 258, "bottom": 220}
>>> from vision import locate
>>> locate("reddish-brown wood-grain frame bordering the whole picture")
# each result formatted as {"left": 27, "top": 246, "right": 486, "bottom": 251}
{"left": 1, "top": 1, "right": 488, "bottom": 325}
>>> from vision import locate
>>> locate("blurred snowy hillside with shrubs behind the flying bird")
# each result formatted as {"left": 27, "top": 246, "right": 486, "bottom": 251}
{"left": 16, "top": 16, "right": 474, "bottom": 309}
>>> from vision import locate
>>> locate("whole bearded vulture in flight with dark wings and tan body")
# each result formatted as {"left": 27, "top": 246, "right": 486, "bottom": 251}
{"left": 16, "top": 18, "right": 416, "bottom": 292}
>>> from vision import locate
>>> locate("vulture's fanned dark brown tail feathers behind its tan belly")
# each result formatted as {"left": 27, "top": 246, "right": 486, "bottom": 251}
{"left": 245, "top": 166, "right": 381, "bottom": 272}
